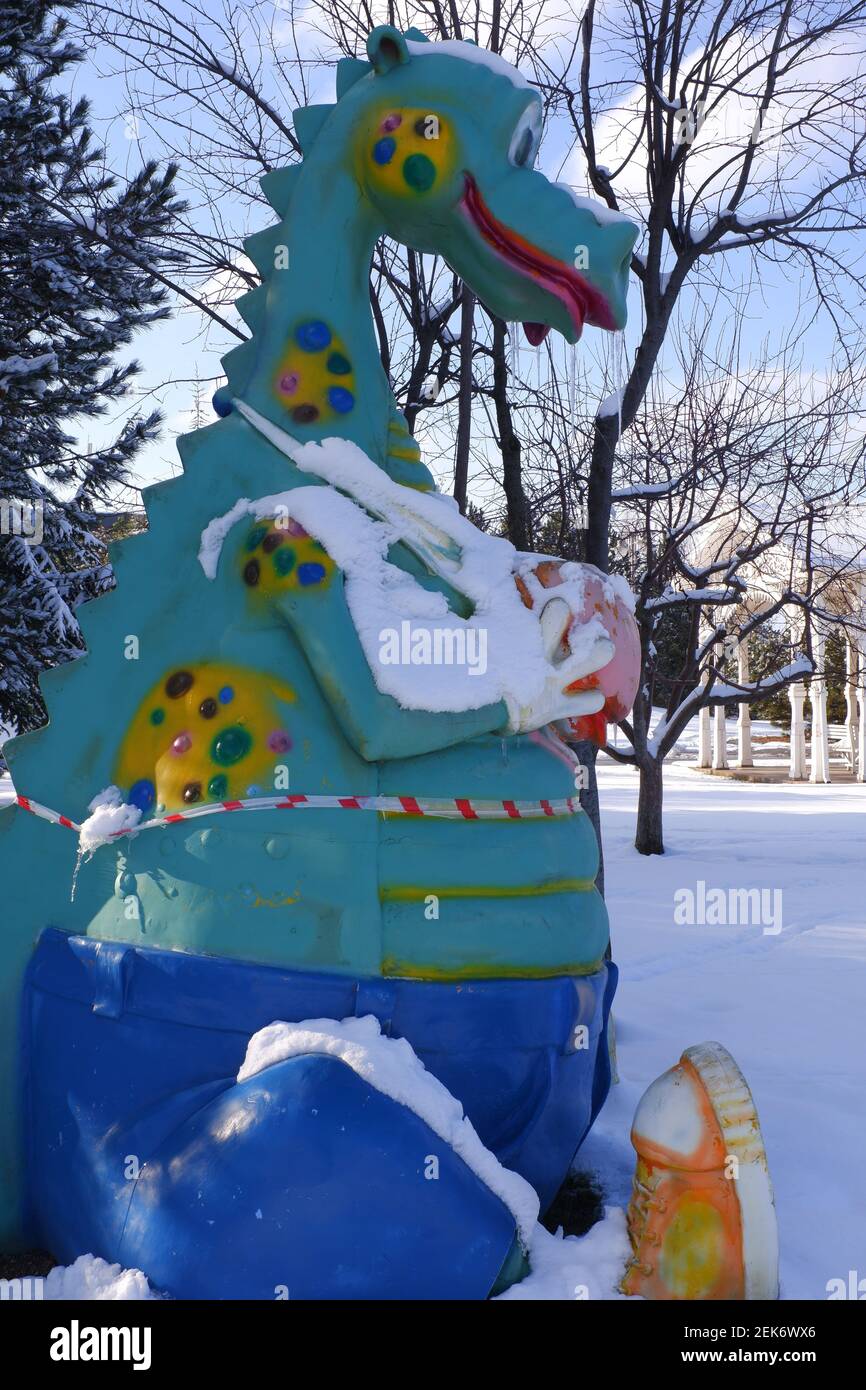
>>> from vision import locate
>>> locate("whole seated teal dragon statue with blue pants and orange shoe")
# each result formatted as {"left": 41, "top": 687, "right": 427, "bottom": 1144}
{"left": 0, "top": 26, "right": 776, "bottom": 1298}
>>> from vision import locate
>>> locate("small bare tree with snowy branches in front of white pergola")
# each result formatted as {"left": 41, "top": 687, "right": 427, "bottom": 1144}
{"left": 607, "top": 324, "right": 866, "bottom": 853}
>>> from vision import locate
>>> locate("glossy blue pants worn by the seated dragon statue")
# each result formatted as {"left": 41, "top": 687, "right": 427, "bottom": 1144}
{"left": 22, "top": 930, "right": 616, "bottom": 1298}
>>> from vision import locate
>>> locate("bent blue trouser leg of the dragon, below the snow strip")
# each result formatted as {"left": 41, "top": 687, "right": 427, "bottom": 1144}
{"left": 115, "top": 1055, "right": 514, "bottom": 1298}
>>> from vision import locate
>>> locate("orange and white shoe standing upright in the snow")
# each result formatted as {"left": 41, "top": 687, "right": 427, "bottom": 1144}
{"left": 620, "top": 1043, "right": 778, "bottom": 1300}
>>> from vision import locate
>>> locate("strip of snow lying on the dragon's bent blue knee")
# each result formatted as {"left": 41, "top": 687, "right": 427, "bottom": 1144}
{"left": 238, "top": 1013, "right": 538, "bottom": 1248}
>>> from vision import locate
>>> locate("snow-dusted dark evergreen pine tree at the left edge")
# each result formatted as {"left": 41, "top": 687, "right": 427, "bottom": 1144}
{"left": 0, "top": 0, "right": 182, "bottom": 731}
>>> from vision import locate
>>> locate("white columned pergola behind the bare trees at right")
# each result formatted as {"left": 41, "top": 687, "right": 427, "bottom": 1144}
{"left": 696, "top": 522, "right": 866, "bottom": 783}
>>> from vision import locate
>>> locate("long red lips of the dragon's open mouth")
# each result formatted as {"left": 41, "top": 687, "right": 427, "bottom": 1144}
{"left": 460, "top": 174, "right": 616, "bottom": 346}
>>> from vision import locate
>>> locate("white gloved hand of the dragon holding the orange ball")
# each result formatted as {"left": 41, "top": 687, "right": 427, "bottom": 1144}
{"left": 503, "top": 599, "right": 614, "bottom": 734}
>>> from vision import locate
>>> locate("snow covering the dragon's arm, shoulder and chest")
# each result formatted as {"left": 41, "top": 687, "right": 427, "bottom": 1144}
{"left": 199, "top": 402, "right": 623, "bottom": 717}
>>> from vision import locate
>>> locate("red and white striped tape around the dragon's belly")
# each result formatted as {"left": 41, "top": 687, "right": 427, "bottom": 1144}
{"left": 15, "top": 795, "right": 581, "bottom": 840}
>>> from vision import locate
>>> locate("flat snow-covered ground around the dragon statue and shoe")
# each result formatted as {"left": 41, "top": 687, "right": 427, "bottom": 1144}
{"left": 0, "top": 738, "right": 866, "bottom": 1298}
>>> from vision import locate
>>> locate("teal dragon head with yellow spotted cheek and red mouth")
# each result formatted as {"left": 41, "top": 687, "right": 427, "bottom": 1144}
{"left": 354, "top": 25, "right": 637, "bottom": 343}
